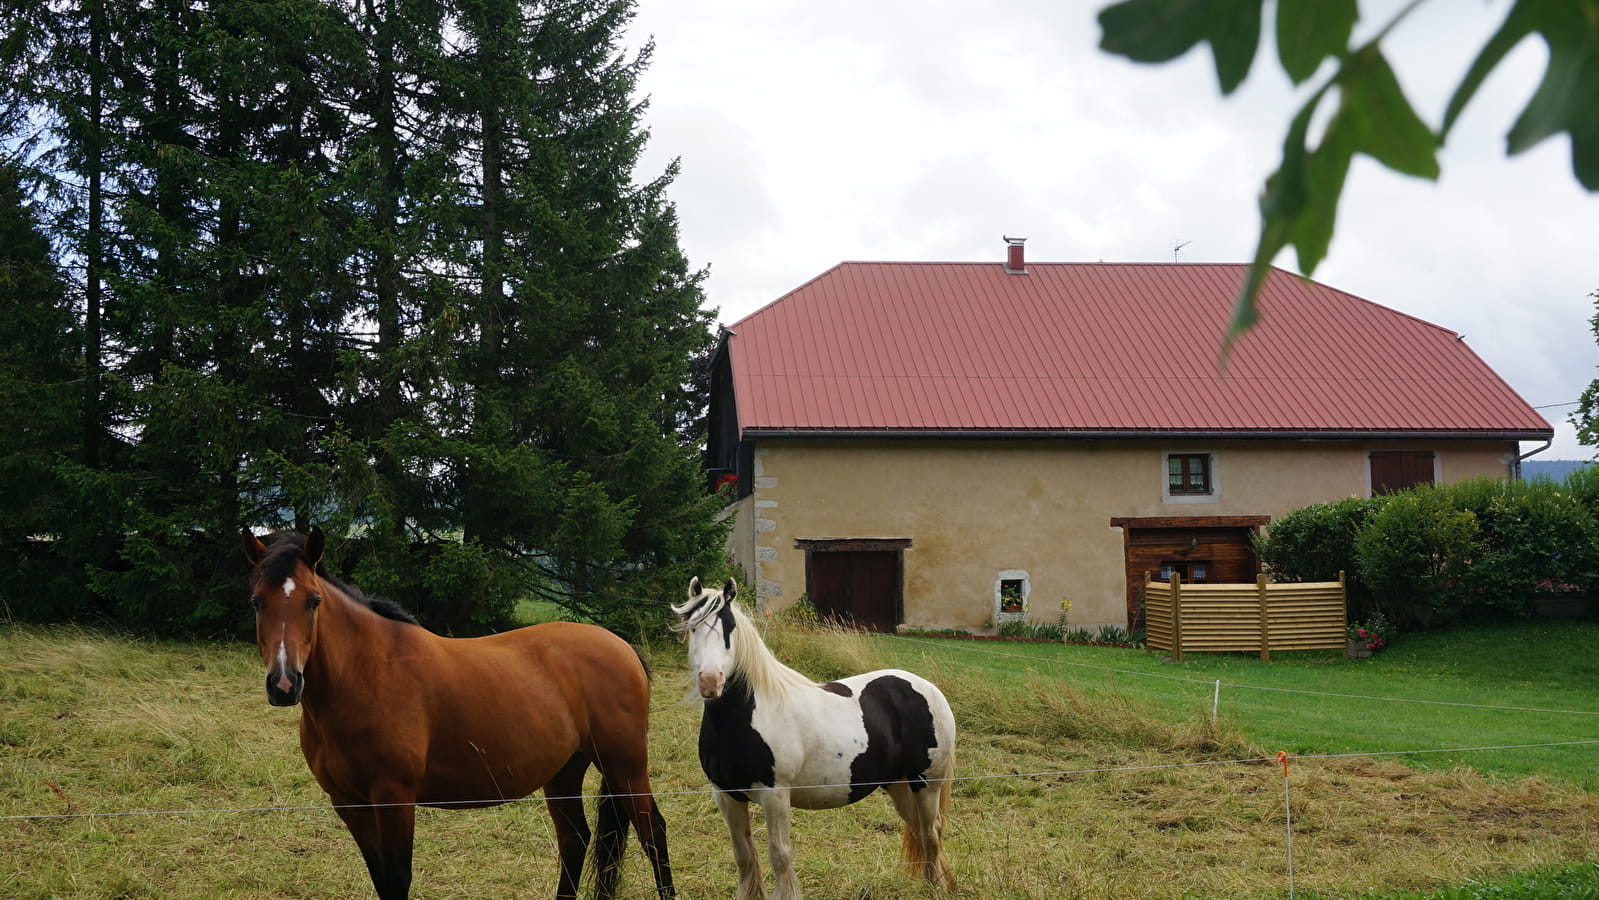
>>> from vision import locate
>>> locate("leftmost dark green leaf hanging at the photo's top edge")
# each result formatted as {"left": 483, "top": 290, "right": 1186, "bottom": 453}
{"left": 1099, "top": 0, "right": 1265, "bottom": 94}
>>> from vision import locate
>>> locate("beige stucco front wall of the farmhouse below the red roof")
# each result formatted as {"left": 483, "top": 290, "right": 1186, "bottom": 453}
{"left": 729, "top": 440, "right": 1517, "bottom": 628}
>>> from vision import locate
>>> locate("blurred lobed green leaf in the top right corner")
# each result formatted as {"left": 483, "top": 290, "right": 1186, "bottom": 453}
{"left": 1441, "top": 0, "right": 1599, "bottom": 190}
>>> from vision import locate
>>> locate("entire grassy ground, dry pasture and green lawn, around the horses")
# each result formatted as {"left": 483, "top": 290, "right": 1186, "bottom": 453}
{"left": 0, "top": 623, "right": 1599, "bottom": 900}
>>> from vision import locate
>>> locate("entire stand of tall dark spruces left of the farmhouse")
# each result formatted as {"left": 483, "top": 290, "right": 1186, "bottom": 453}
{"left": 0, "top": 0, "right": 721, "bottom": 630}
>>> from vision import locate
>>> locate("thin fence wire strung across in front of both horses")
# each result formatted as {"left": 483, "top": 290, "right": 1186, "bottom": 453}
{"left": 0, "top": 739, "right": 1599, "bottom": 822}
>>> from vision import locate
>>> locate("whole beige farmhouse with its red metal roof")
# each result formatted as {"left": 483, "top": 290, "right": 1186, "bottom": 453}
{"left": 707, "top": 238, "right": 1553, "bottom": 630}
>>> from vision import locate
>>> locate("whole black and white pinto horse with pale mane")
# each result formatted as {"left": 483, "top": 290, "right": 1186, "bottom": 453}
{"left": 672, "top": 577, "right": 955, "bottom": 900}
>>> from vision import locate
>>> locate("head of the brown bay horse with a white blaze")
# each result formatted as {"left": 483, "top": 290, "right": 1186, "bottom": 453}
{"left": 245, "top": 528, "right": 323, "bottom": 707}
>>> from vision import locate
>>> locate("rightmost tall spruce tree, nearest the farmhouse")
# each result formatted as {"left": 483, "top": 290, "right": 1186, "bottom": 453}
{"left": 428, "top": 0, "right": 720, "bottom": 625}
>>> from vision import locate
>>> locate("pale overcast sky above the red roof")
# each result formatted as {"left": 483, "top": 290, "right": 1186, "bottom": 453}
{"left": 632, "top": 0, "right": 1599, "bottom": 459}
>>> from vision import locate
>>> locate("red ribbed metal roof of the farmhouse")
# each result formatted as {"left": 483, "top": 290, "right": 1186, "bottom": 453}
{"left": 728, "top": 262, "right": 1553, "bottom": 440}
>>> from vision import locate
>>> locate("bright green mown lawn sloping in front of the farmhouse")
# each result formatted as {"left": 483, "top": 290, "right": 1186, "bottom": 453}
{"left": 886, "top": 620, "right": 1599, "bottom": 791}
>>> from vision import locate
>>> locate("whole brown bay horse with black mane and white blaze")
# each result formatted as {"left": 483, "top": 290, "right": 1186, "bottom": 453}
{"left": 245, "top": 529, "right": 675, "bottom": 900}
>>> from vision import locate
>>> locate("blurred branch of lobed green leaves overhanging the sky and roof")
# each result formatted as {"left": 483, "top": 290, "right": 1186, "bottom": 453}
{"left": 1099, "top": 0, "right": 1599, "bottom": 351}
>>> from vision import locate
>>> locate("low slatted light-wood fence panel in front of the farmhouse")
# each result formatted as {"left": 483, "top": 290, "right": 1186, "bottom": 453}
{"left": 1143, "top": 572, "right": 1348, "bottom": 662}
